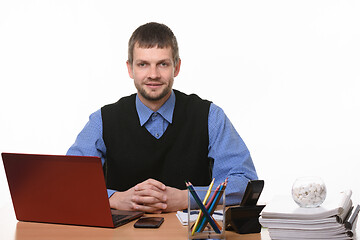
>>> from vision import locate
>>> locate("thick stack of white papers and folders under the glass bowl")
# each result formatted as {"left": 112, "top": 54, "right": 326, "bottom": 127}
{"left": 259, "top": 190, "right": 359, "bottom": 240}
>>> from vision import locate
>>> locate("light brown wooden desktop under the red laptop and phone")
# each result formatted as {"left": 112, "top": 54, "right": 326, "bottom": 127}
{"left": 0, "top": 205, "right": 270, "bottom": 240}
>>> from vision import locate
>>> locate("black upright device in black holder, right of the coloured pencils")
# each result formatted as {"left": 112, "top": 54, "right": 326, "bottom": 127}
{"left": 225, "top": 180, "right": 265, "bottom": 234}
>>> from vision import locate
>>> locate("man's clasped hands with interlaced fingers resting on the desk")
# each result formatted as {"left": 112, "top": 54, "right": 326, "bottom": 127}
{"left": 109, "top": 179, "right": 187, "bottom": 213}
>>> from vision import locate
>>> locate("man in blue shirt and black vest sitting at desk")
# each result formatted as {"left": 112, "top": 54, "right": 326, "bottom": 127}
{"left": 67, "top": 23, "right": 257, "bottom": 213}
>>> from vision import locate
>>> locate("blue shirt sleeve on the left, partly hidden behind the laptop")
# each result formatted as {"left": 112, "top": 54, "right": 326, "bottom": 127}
{"left": 66, "top": 109, "right": 115, "bottom": 197}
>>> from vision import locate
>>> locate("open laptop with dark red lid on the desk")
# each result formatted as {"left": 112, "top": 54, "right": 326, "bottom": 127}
{"left": 2, "top": 153, "right": 144, "bottom": 228}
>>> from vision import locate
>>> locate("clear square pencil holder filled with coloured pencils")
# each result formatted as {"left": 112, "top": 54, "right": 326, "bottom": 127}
{"left": 187, "top": 190, "right": 226, "bottom": 239}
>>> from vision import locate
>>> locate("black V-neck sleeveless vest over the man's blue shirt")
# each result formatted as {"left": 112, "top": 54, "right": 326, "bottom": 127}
{"left": 101, "top": 90, "right": 213, "bottom": 191}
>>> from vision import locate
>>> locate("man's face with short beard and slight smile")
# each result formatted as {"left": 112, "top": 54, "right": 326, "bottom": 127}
{"left": 127, "top": 44, "right": 180, "bottom": 105}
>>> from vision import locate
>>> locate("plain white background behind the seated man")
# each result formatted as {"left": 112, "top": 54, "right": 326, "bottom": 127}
{"left": 0, "top": 0, "right": 360, "bottom": 206}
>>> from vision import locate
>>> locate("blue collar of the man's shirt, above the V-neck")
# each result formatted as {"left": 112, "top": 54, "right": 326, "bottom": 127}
{"left": 135, "top": 91, "right": 175, "bottom": 126}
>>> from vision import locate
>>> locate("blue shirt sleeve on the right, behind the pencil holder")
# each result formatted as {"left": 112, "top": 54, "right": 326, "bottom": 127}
{"left": 193, "top": 103, "right": 258, "bottom": 205}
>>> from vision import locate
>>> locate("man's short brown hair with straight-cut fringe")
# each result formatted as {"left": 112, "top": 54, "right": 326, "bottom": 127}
{"left": 128, "top": 22, "right": 179, "bottom": 65}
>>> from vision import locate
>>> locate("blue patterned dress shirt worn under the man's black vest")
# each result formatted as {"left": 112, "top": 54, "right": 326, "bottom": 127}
{"left": 67, "top": 92, "right": 257, "bottom": 205}
